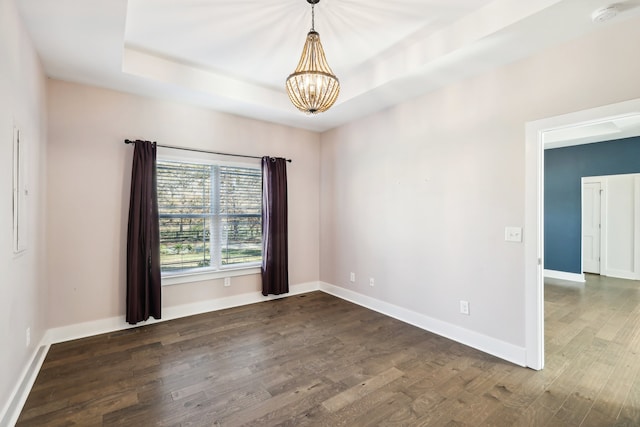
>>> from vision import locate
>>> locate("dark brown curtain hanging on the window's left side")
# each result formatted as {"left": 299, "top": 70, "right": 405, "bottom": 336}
{"left": 127, "top": 141, "right": 161, "bottom": 325}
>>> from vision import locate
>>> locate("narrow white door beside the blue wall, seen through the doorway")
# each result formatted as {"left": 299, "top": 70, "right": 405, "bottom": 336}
{"left": 582, "top": 182, "right": 602, "bottom": 274}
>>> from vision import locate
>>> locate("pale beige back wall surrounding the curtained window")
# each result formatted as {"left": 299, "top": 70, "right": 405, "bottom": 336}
{"left": 47, "top": 80, "right": 320, "bottom": 328}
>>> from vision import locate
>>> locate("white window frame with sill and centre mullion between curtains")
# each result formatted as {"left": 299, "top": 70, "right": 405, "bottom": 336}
{"left": 156, "top": 147, "right": 262, "bottom": 286}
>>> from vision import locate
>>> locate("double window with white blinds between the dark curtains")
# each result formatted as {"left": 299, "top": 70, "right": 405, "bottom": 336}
{"left": 157, "top": 160, "right": 262, "bottom": 276}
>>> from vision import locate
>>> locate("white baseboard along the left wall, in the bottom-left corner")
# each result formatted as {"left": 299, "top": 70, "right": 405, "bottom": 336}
{"left": 0, "top": 338, "right": 49, "bottom": 427}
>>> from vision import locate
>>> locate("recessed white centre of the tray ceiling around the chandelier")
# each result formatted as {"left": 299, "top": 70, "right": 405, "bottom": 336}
{"left": 125, "top": 0, "right": 496, "bottom": 87}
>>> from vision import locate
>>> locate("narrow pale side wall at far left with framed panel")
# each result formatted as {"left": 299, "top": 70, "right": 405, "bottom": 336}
{"left": 0, "top": 0, "right": 47, "bottom": 424}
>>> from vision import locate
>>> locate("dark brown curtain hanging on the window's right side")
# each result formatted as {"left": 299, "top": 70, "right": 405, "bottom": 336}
{"left": 262, "top": 157, "right": 289, "bottom": 295}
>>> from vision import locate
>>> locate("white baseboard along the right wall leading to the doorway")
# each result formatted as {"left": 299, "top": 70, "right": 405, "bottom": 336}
{"left": 320, "top": 282, "right": 527, "bottom": 366}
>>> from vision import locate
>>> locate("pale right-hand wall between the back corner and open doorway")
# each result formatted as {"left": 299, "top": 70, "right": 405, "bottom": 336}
{"left": 320, "top": 14, "right": 640, "bottom": 362}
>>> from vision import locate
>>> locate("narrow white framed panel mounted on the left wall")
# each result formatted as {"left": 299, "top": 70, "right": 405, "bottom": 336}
{"left": 13, "top": 126, "right": 29, "bottom": 253}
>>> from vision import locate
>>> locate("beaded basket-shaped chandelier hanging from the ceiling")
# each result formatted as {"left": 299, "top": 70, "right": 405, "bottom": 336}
{"left": 287, "top": 0, "right": 340, "bottom": 114}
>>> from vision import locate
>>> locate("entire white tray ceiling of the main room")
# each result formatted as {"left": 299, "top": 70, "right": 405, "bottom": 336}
{"left": 17, "top": 0, "right": 640, "bottom": 131}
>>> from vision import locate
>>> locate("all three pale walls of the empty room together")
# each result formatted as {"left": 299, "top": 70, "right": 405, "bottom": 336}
{"left": 7, "top": 0, "right": 640, "bottom": 408}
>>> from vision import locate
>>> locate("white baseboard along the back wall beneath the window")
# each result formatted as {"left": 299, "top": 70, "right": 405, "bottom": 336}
{"left": 45, "top": 282, "right": 319, "bottom": 344}
